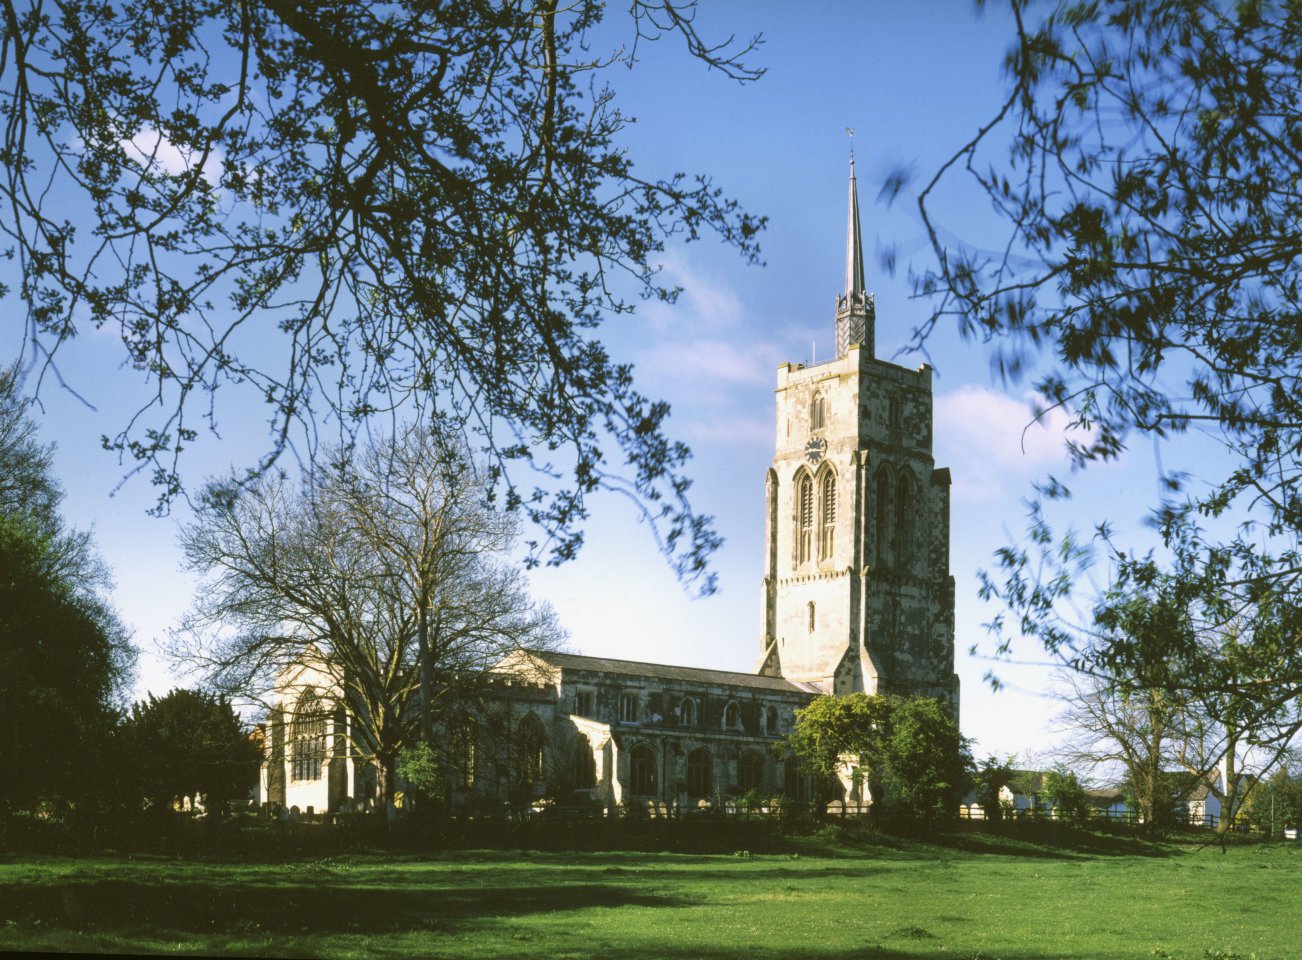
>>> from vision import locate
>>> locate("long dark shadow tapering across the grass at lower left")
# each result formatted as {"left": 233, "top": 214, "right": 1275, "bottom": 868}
{"left": 0, "top": 877, "right": 684, "bottom": 934}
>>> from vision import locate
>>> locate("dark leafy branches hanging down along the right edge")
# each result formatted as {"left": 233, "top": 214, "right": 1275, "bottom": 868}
{"left": 918, "top": 0, "right": 1302, "bottom": 742}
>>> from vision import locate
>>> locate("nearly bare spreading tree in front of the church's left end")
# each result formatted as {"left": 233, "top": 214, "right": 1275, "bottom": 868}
{"left": 176, "top": 427, "right": 561, "bottom": 800}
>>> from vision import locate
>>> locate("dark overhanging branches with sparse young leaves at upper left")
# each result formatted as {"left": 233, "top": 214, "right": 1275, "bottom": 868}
{"left": 0, "top": 0, "right": 763, "bottom": 589}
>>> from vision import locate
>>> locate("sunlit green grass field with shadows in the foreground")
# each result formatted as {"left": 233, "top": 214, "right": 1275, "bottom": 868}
{"left": 0, "top": 839, "right": 1302, "bottom": 960}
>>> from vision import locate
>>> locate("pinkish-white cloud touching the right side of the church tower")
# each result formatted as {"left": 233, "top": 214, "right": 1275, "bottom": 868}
{"left": 935, "top": 387, "right": 1087, "bottom": 500}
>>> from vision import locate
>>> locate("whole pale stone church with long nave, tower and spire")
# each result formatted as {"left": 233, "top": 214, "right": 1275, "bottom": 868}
{"left": 260, "top": 156, "right": 958, "bottom": 810}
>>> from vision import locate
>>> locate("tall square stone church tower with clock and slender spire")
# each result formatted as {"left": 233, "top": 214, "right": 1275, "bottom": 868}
{"left": 759, "top": 155, "right": 958, "bottom": 719}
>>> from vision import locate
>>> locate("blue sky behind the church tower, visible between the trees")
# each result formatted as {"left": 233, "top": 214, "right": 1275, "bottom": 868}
{"left": 0, "top": 0, "right": 1218, "bottom": 757}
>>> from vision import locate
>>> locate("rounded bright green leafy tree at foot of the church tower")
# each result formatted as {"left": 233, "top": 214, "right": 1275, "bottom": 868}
{"left": 786, "top": 693, "right": 973, "bottom": 822}
